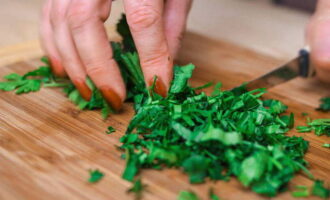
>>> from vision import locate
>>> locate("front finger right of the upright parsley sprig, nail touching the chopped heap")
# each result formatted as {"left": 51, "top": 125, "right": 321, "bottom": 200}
{"left": 124, "top": 0, "right": 173, "bottom": 97}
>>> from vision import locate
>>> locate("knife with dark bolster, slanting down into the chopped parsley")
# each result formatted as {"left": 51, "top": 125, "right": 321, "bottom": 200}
{"left": 242, "top": 47, "right": 315, "bottom": 90}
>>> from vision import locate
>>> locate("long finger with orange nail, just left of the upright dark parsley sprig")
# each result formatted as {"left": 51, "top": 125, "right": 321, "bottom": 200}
{"left": 69, "top": 0, "right": 126, "bottom": 111}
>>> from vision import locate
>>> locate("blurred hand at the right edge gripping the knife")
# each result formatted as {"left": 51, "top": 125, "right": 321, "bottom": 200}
{"left": 306, "top": 0, "right": 330, "bottom": 83}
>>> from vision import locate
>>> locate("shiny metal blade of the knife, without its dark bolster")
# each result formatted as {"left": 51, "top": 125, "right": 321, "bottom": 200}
{"left": 246, "top": 57, "right": 300, "bottom": 90}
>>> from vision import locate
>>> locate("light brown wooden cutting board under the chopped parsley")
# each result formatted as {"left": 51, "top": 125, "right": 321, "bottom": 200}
{"left": 0, "top": 33, "right": 330, "bottom": 200}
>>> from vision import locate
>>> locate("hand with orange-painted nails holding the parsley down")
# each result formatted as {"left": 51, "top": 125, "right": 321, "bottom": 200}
{"left": 41, "top": 0, "right": 192, "bottom": 110}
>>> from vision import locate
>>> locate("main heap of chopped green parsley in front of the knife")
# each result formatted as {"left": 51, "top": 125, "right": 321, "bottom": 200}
{"left": 121, "top": 64, "right": 308, "bottom": 196}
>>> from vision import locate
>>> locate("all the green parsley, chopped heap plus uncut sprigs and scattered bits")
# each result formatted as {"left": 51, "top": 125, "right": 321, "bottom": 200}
{"left": 0, "top": 14, "right": 330, "bottom": 199}
